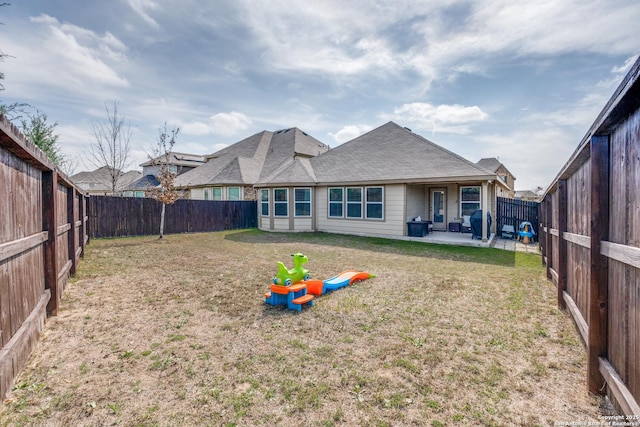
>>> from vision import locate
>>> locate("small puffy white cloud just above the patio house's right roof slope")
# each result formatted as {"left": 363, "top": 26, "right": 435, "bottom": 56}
{"left": 390, "top": 102, "right": 489, "bottom": 134}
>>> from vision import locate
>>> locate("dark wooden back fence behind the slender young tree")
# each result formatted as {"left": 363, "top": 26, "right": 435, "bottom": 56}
{"left": 87, "top": 196, "right": 258, "bottom": 238}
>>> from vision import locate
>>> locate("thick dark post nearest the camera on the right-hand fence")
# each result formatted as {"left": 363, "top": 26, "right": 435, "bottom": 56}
{"left": 587, "top": 135, "right": 609, "bottom": 394}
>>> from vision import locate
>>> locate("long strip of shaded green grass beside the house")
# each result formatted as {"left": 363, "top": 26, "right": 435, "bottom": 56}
{"left": 225, "top": 229, "right": 541, "bottom": 267}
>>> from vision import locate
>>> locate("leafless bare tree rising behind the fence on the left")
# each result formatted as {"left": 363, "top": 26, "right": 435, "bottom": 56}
{"left": 89, "top": 101, "right": 132, "bottom": 193}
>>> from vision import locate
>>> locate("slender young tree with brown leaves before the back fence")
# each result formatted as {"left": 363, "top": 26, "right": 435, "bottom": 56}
{"left": 146, "top": 122, "right": 182, "bottom": 239}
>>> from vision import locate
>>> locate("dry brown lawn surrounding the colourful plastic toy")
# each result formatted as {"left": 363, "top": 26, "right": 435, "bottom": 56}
{"left": 0, "top": 230, "right": 600, "bottom": 427}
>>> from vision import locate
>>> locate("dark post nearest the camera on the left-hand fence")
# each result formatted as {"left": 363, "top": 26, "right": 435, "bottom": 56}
{"left": 42, "top": 170, "right": 60, "bottom": 316}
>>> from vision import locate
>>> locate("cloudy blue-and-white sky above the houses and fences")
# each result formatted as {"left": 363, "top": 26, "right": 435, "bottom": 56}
{"left": 0, "top": 0, "right": 640, "bottom": 190}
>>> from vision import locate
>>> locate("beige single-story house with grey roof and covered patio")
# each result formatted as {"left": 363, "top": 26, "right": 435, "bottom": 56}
{"left": 255, "top": 122, "right": 513, "bottom": 241}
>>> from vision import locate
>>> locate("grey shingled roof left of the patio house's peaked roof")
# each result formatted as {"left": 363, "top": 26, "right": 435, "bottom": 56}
{"left": 175, "top": 128, "right": 329, "bottom": 187}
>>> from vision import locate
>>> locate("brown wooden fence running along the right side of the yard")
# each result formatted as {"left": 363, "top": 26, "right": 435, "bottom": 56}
{"left": 540, "top": 59, "right": 640, "bottom": 415}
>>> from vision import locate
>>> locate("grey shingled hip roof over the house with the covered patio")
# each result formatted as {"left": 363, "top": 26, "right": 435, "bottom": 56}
{"left": 278, "top": 122, "right": 502, "bottom": 184}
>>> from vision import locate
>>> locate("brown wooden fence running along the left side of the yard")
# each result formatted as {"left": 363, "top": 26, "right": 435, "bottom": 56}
{"left": 0, "top": 115, "right": 86, "bottom": 404}
